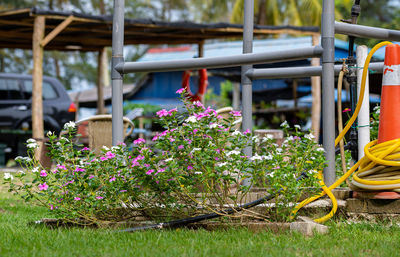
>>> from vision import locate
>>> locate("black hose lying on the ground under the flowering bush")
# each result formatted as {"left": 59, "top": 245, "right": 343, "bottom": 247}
{"left": 118, "top": 172, "right": 307, "bottom": 232}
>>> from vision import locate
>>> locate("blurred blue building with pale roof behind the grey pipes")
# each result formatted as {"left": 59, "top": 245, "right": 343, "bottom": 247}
{"left": 128, "top": 36, "right": 383, "bottom": 107}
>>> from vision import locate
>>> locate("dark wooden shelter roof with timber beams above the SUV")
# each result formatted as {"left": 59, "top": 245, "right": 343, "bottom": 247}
{"left": 0, "top": 8, "right": 319, "bottom": 51}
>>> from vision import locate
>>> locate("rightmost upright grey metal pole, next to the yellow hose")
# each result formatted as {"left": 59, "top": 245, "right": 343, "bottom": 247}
{"left": 321, "top": 0, "right": 335, "bottom": 186}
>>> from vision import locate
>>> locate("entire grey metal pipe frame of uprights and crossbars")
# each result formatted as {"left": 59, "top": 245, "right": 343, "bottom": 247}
{"left": 111, "top": 0, "right": 400, "bottom": 185}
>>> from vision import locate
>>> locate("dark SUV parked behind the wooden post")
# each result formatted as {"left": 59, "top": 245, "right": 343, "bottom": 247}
{"left": 0, "top": 73, "right": 76, "bottom": 158}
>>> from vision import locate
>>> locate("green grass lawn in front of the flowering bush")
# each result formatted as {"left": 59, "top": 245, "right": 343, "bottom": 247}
{"left": 0, "top": 191, "right": 400, "bottom": 257}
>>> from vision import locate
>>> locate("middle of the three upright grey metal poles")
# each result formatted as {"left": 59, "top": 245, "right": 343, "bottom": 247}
{"left": 241, "top": 0, "right": 254, "bottom": 150}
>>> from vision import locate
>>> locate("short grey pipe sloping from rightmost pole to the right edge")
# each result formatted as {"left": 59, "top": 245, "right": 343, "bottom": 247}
{"left": 335, "top": 21, "right": 400, "bottom": 41}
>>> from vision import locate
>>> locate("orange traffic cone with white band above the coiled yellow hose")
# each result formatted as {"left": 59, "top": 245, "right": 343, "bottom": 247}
{"left": 378, "top": 44, "right": 400, "bottom": 143}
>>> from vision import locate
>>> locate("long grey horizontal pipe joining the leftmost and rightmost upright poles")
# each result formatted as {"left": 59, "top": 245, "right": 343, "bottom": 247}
{"left": 115, "top": 46, "right": 323, "bottom": 74}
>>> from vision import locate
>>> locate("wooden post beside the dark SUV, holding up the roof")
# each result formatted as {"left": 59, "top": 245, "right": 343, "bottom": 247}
{"left": 32, "top": 16, "right": 46, "bottom": 159}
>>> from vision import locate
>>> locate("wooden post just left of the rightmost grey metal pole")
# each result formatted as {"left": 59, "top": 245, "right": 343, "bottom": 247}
{"left": 311, "top": 35, "right": 321, "bottom": 142}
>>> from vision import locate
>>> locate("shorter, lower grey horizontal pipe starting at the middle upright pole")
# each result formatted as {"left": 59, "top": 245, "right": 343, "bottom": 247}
{"left": 246, "top": 62, "right": 383, "bottom": 80}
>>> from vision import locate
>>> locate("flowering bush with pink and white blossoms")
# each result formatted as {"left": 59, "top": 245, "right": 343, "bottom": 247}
{"left": 5, "top": 89, "right": 325, "bottom": 223}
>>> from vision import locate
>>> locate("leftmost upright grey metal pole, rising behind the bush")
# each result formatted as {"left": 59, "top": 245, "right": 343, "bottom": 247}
{"left": 111, "top": 0, "right": 125, "bottom": 145}
